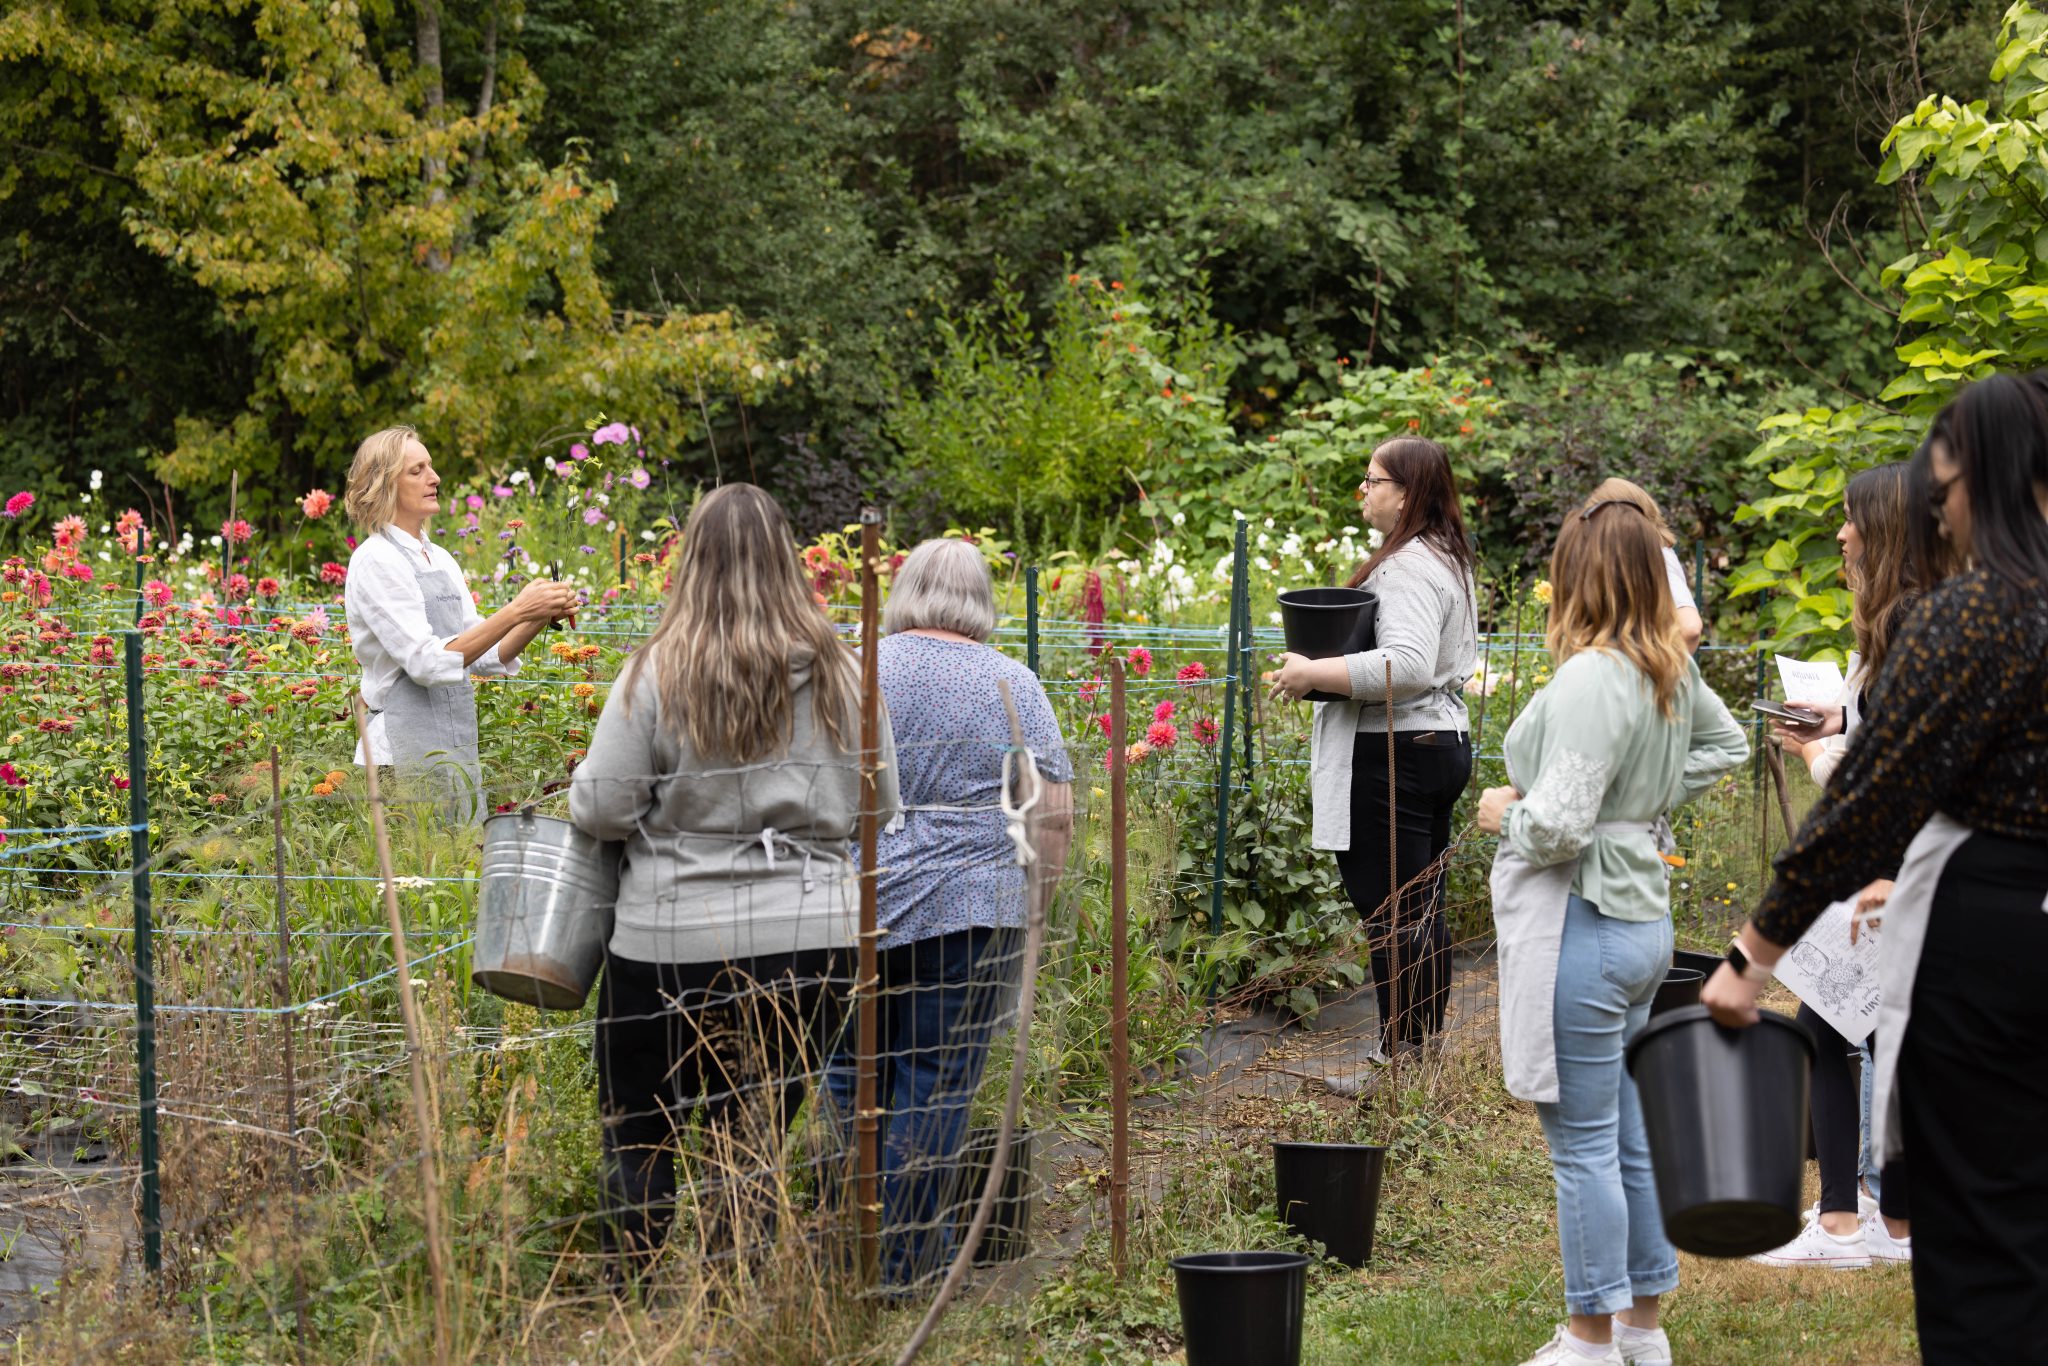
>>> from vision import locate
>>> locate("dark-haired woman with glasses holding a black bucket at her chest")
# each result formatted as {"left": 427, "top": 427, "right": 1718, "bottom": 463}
{"left": 1274, "top": 436, "right": 1479, "bottom": 1055}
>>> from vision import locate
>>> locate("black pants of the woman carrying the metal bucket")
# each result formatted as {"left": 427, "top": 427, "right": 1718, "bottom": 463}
{"left": 596, "top": 948, "right": 850, "bottom": 1272}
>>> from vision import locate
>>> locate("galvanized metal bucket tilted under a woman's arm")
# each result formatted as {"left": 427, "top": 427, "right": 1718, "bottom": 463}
{"left": 469, "top": 811, "right": 623, "bottom": 1010}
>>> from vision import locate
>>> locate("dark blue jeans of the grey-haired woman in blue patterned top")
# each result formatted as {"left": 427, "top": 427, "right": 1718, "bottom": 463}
{"left": 825, "top": 930, "right": 1024, "bottom": 1286}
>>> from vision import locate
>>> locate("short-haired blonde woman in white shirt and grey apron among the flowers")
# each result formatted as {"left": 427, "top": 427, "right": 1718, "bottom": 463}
{"left": 344, "top": 426, "right": 578, "bottom": 821}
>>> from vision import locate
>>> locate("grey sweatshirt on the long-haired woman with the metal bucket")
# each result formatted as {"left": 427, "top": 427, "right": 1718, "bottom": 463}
{"left": 569, "top": 657, "right": 899, "bottom": 963}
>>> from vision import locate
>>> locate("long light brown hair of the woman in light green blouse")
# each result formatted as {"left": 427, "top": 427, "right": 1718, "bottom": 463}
{"left": 1546, "top": 498, "right": 1686, "bottom": 721}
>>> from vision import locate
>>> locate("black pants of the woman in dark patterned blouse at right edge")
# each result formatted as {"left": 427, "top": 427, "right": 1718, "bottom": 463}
{"left": 1886, "top": 834, "right": 2048, "bottom": 1366}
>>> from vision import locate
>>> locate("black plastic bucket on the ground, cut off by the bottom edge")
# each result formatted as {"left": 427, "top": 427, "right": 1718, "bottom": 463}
{"left": 1174, "top": 1251, "right": 1309, "bottom": 1366}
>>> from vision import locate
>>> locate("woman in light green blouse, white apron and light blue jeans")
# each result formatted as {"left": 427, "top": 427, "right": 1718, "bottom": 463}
{"left": 1479, "top": 498, "right": 1749, "bottom": 1366}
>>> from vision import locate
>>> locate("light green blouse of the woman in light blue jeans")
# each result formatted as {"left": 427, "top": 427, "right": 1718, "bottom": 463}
{"left": 1501, "top": 649, "right": 1749, "bottom": 922}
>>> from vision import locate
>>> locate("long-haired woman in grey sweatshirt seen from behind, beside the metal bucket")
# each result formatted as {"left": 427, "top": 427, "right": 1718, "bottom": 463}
{"left": 569, "top": 483, "right": 897, "bottom": 1270}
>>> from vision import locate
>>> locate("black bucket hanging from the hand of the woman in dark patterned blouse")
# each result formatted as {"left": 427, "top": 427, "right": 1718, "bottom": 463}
{"left": 1628, "top": 1006, "right": 1812, "bottom": 1257}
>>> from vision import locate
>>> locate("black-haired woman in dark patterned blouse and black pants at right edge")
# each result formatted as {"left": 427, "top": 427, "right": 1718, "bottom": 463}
{"left": 1700, "top": 375, "right": 2048, "bottom": 1362}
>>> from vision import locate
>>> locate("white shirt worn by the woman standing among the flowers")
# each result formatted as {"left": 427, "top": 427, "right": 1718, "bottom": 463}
{"left": 342, "top": 526, "right": 518, "bottom": 764}
